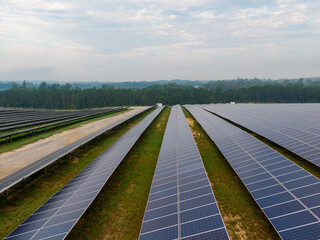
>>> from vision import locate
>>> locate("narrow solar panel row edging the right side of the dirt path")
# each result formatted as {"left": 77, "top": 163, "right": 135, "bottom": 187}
{"left": 0, "top": 107, "right": 151, "bottom": 193}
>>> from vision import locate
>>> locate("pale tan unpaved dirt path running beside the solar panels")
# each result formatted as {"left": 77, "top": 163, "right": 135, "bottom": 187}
{"left": 0, "top": 107, "right": 146, "bottom": 179}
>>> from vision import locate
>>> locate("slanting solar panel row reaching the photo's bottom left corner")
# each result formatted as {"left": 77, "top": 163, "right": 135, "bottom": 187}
{"left": 5, "top": 108, "right": 163, "bottom": 240}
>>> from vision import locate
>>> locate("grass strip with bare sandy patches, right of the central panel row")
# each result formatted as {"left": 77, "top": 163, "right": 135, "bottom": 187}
{"left": 183, "top": 109, "right": 280, "bottom": 240}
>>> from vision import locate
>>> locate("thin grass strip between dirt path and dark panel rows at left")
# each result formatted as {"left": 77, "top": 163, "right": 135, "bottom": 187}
{"left": 0, "top": 110, "right": 130, "bottom": 154}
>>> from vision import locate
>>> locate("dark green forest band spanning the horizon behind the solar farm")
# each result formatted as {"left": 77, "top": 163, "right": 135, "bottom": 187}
{"left": 0, "top": 79, "right": 320, "bottom": 109}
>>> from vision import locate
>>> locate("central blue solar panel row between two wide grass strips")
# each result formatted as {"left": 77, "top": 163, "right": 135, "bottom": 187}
{"left": 139, "top": 106, "right": 229, "bottom": 240}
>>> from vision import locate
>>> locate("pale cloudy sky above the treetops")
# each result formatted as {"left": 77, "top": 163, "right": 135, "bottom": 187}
{"left": 0, "top": 0, "right": 320, "bottom": 82}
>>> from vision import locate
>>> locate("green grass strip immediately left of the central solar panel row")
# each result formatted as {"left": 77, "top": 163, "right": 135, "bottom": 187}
{"left": 67, "top": 107, "right": 170, "bottom": 240}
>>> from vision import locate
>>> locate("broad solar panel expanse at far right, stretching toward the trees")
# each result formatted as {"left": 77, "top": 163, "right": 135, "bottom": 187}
{"left": 203, "top": 104, "right": 320, "bottom": 167}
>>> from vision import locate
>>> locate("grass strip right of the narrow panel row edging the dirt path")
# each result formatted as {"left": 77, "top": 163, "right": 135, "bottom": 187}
{"left": 0, "top": 107, "right": 152, "bottom": 239}
